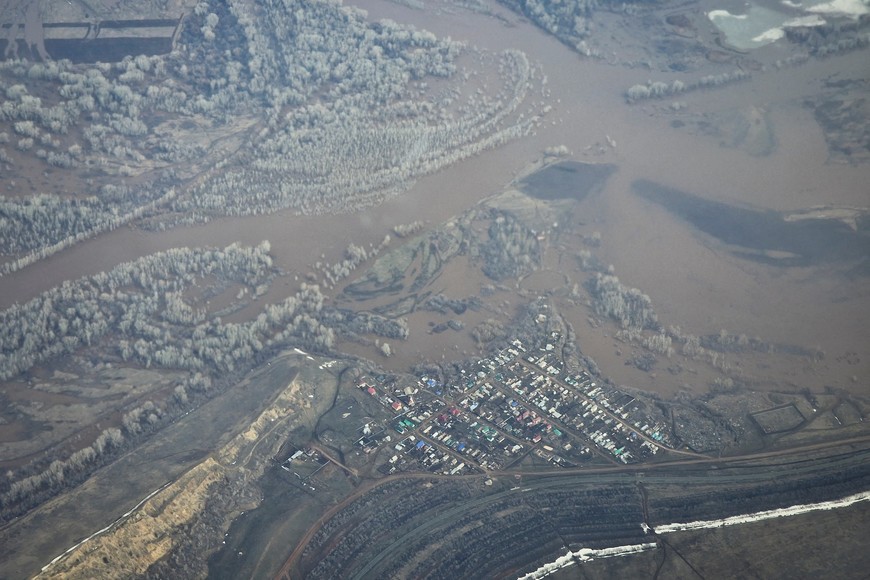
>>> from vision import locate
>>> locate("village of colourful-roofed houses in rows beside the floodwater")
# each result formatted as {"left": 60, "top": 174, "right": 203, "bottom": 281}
{"left": 356, "top": 333, "right": 674, "bottom": 475}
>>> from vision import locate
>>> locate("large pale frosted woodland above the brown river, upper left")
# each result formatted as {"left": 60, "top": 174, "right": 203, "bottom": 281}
{"left": 0, "top": 0, "right": 540, "bottom": 270}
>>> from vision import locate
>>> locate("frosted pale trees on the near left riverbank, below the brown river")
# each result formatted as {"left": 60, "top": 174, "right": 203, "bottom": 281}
{"left": 0, "top": 242, "right": 409, "bottom": 515}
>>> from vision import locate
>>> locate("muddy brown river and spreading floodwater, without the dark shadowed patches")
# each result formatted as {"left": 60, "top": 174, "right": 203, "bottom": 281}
{"left": 0, "top": 0, "right": 870, "bottom": 390}
